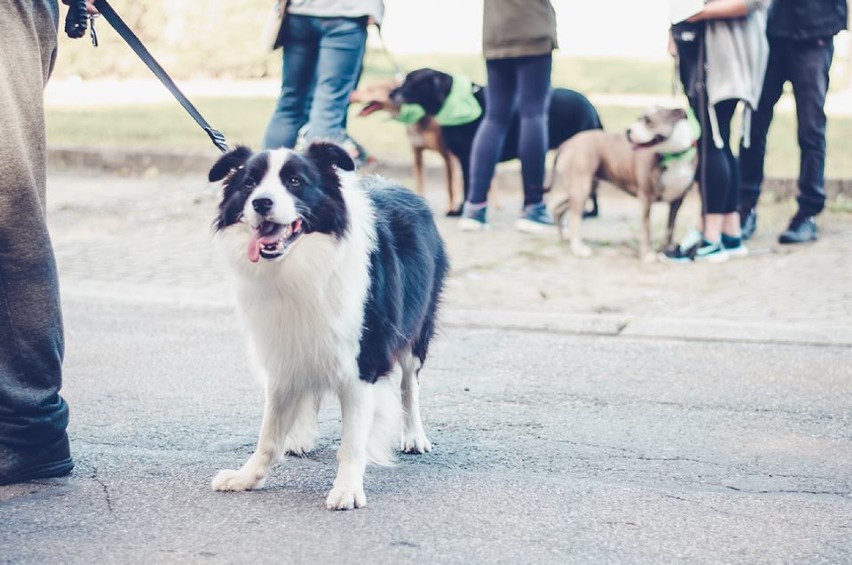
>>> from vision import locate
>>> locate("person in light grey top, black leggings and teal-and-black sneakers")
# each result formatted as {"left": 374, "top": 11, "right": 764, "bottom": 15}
{"left": 663, "top": 0, "right": 771, "bottom": 263}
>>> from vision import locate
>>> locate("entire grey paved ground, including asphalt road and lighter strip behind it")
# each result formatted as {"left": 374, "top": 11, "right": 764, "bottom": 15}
{"left": 0, "top": 165, "right": 852, "bottom": 564}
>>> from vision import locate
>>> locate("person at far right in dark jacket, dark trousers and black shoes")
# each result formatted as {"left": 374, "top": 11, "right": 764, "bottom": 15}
{"left": 740, "top": 0, "right": 848, "bottom": 244}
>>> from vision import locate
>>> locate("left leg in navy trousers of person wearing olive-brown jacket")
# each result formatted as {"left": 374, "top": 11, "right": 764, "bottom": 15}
{"left": 467, "top": 59, "right": 517, "bottom": 206}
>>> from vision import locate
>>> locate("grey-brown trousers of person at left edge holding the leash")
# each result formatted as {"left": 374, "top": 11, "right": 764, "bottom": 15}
{"left": 0, "top": 0, "right": 68, "bottom": 449}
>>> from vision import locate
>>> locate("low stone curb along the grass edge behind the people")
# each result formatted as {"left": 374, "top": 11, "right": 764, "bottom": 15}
{"left": 47, "top": 146, "right": 852, "bottom": 200}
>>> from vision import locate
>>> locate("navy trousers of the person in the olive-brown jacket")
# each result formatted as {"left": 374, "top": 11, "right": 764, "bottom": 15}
{"left": 468, "top": 53, "right": 552, "bottom": 206}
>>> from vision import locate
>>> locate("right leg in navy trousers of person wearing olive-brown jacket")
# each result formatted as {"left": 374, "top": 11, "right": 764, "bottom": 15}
{"left": 516, "top": 54, "right": 552, "bottom": 206}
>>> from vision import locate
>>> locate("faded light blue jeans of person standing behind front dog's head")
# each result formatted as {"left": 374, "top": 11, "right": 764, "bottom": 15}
{"left": 263, "top": 14, "right": 367, "bottom": 149}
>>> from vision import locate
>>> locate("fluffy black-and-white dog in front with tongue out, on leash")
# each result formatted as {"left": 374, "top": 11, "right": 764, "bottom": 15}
{"left": 209, "top": 143, "right": 448, "bottom": 510}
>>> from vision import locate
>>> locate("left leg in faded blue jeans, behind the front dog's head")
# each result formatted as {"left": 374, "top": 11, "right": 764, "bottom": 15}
{"left": 263, "top": 14, "right": 319, "bottom": 149}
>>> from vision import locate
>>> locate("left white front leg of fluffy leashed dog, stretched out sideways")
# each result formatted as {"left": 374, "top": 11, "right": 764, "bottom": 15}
{"left": 212, "top": 387, "right": 296, "bottom": 490}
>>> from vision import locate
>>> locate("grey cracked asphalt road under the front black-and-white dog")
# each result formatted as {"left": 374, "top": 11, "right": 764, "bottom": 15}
{"left": 0, "top": 299, "right": 852, "bottom": 563}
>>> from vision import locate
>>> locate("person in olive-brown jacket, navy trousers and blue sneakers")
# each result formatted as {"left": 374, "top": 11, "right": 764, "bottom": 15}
{"left": 459, "top": 0, "right": 558, "bottom": 232}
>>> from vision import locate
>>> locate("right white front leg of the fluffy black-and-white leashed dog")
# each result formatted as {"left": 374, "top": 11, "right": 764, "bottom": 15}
{"left": 325, "top": 377, "right": 375, "bottom": 510}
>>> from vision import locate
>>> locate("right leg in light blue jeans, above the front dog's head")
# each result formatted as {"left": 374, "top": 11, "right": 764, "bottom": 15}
{"left": 307, "top": 18, "right": 367, "bottom": 143}
